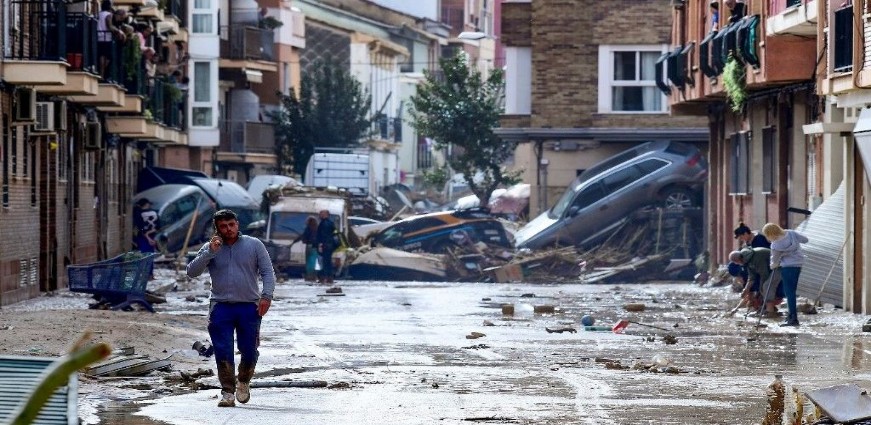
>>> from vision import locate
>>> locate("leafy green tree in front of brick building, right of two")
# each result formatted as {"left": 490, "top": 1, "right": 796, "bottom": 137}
{"left": 410, "top": 52, "right": 517, "bottom": 205}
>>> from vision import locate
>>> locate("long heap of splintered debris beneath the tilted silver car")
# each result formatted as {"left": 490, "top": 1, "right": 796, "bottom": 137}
{"left": 350, "top": 205, "right": 700, "bottom": 283}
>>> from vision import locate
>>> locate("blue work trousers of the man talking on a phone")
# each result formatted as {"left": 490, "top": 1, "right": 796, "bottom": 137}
{"left": 209, "top": 302, "right": 261, "bottom": 369}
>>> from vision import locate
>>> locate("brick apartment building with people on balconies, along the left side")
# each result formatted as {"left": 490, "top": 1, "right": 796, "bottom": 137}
{"left": 0, "top": 0, "right": 187, "bottom": 305}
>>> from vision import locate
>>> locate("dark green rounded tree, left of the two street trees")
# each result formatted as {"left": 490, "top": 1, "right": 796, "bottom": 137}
{"left": 273, "top": 61, "right": 371, "bottom": 174}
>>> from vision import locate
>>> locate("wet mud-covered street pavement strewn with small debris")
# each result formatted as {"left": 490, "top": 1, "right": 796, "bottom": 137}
{"left": 78, "top": 281, "right": 871, "bottom": 425}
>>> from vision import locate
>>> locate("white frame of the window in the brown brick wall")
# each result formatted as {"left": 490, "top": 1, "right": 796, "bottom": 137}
{"left": 598, "top": 44, "right": 669, "bottom": 115}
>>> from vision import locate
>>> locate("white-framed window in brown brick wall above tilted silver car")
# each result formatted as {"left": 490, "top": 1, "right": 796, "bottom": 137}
{"left": 599, "top": 45, "right": 668, "bottom": 113}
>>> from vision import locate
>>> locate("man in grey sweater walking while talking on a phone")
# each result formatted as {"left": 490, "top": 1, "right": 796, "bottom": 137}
{"left": 187, "top": 210, "right": 275, "bottom": 407}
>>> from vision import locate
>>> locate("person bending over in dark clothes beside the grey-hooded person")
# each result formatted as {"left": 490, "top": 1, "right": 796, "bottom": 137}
{"left": 729, "top": 248, "right": 783, "bottom": 317}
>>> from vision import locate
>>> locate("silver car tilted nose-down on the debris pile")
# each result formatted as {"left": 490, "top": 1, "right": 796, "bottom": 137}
{"left": 514, "top": 141, "right": 708, "bottom": 249}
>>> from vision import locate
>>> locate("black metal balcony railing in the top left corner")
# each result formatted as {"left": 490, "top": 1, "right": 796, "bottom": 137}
{"left": 5, "top": 0, "right": 67, "bottom": 61}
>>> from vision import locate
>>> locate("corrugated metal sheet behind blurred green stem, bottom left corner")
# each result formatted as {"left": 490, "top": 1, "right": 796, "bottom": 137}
{"left": 0, "top": 356, "right": 79, "bottom": 425}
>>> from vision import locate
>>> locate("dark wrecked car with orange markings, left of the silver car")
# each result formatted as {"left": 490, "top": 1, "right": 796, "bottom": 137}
{"left": 370, "top": 208, "right": 511, "bottom": 254}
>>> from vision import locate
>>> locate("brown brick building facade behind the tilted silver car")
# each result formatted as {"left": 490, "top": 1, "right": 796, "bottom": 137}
{"left": 496, "top": 0, "right": 708, "bottom": 216}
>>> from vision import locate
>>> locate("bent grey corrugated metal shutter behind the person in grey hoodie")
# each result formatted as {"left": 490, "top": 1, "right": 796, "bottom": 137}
{"left": 796, "top": 182, "right": 846, "bottom": 306}
